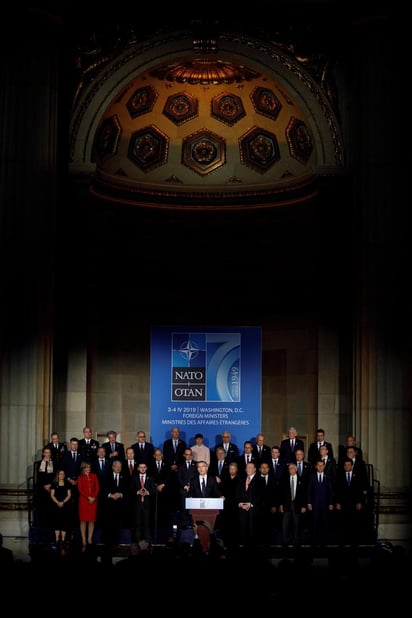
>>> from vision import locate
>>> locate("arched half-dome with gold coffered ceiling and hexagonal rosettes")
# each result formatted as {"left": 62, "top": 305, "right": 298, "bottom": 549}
{"left": 71, "top": 24, "right": 343, "bottom": 208}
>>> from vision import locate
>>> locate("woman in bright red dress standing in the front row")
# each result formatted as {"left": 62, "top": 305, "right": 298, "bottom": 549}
{"left": 77, "top": 461, "right": 99, "bottom": 551}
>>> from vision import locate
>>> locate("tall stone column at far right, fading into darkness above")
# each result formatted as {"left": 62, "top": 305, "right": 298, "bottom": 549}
{"left": 352, "top": 18, "right": 412, "bottom": 537}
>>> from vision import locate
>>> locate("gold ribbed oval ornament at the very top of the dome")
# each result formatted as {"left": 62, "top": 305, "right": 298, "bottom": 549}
{"left": 150, "top": 59, "right": 261, "bottom": 86}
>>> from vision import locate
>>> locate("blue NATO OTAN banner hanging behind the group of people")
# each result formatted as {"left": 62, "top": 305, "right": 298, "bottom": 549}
{"left": 150, "top": 326, "right": 262, "bottom": 452}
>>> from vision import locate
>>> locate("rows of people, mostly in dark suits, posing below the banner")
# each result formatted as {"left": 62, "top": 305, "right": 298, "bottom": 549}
{"left": 36, "top": 427, "right": 369, "bottom": 547}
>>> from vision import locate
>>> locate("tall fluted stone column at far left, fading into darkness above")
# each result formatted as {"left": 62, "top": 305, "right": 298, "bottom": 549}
{"left": 0, "top": 12, "right": 58, "bottom": 491}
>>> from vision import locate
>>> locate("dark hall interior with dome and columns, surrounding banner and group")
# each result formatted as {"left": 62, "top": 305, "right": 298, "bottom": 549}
{"left": 0, "top": 0, "right": 412, "bottom": 584}
